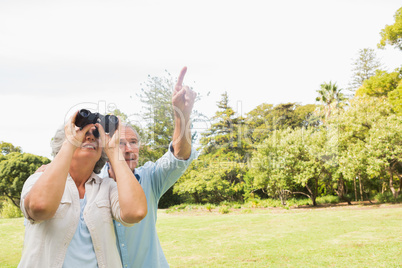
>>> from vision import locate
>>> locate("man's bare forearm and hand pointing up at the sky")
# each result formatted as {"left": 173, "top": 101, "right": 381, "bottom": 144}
{"left": 172, "top": 67, "right": 197, "bottom": 159}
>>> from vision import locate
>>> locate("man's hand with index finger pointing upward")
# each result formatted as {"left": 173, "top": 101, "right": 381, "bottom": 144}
{"left": 172, "top": 67, "right": 197, "bottom": 121}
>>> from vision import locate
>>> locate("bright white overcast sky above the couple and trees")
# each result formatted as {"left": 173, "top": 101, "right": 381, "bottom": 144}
{"left": 0, "top": 0, "right": 402, "bottom": 158}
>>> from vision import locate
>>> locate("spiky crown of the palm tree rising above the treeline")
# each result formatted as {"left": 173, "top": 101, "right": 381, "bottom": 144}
{"left": 315, "top": 81, "right": 347, "bottom": 118}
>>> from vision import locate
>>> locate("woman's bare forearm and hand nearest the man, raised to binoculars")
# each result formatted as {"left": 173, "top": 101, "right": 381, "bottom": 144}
{"left": 97, "top": 124, "right": 148, "bottom": 223}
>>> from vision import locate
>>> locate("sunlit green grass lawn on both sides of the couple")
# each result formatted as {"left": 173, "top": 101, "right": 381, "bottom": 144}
{"left": 0, "top": 205, "right": 402, "bottom": 268}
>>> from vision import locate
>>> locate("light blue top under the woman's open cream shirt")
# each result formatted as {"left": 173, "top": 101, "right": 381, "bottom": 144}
{"left": 63, "top": 195, "right": 98, "bottom": 268}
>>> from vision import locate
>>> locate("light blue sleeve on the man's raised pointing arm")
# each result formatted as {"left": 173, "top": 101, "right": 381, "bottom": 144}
{"left": 149, "top": 143, "right": 198, "bottom": 199}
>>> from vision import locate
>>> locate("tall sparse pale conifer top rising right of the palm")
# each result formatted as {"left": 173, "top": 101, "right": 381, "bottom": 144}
{"left": 350, "top": 48, "right": 382, "bottom": 92}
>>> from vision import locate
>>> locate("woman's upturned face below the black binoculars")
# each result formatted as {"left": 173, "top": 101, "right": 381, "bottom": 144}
{"left": 73, "top": 127, "right": 102, "bottom": 162}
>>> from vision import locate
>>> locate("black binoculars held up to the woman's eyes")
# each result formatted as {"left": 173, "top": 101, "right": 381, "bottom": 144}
{"left": 75, "top": 109, "right": 119, "bottom": 138}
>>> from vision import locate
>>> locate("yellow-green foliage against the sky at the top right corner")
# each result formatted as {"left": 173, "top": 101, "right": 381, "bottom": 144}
{"left": 377, "top": 7, "right": 402, "bottom": 50}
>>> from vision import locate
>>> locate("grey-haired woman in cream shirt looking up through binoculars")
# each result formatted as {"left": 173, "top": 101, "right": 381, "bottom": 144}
{"left": 18, "top": 110, "right": 147, "bottom": 268}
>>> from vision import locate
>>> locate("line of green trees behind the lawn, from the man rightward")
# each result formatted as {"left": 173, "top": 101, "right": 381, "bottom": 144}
{"left": 131, "top": 8, "right": 402, "bottom": 207}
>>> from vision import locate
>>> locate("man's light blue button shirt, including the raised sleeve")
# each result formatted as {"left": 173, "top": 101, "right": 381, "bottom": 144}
{"left": 100, "top": 145, "right": 197, "bottom": 268}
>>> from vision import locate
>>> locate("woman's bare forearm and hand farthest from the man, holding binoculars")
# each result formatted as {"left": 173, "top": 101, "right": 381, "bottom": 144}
{"left": 24, "top": 112, "right": 93, "bottom": 221}
